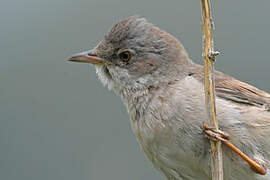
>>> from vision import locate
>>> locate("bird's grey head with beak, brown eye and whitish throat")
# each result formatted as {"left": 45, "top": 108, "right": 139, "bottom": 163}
{"left": 69, "top": 16, "right": 191, "bottom": 94}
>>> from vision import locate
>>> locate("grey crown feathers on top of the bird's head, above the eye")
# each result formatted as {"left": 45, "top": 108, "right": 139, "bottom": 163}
{"left": 105, "top": 16, "right": 168, "bottom": 54}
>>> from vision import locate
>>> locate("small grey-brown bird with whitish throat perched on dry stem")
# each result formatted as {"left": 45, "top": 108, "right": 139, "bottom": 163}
{"left": 68, "top": 16, "right": 270, "bottom": 180}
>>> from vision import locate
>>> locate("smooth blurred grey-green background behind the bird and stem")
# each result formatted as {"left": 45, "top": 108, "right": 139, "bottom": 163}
{"left": 0, "top": 0, "right": 270, "bottom": 180}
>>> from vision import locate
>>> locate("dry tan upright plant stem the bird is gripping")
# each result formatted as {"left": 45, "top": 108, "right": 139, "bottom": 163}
{"left": 201, "top": 0, "right": 223, "bottom": 180}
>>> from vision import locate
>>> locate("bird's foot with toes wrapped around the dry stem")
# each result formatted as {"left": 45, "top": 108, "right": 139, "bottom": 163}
{"left": 201, "top": 122, "right": 230, "bottom": 142}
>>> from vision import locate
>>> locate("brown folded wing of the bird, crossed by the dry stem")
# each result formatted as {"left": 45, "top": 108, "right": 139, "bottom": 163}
{"left": 190, "top": 65, "right": 270, "bottom": 111}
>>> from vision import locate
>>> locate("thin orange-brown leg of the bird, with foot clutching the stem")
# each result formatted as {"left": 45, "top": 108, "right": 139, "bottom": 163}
{"left": 201, "top": 122, "right": 267, "bottom": 175}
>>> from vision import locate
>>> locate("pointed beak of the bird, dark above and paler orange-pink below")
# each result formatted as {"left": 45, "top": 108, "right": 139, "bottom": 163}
{"left": 68, "top": 50, "right": 105, "bottom": 65}
